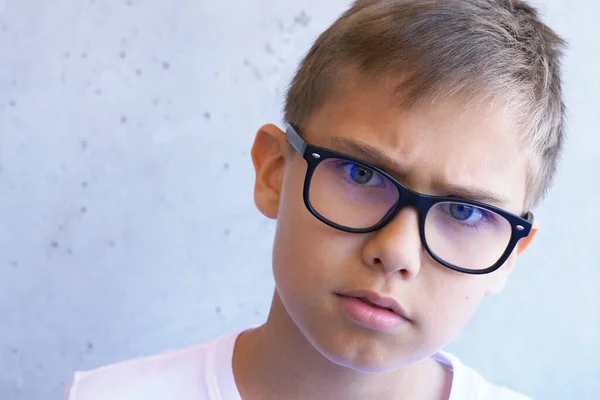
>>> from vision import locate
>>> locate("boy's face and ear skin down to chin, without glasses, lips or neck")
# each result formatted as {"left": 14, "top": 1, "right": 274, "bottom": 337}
{"left": 253, "top": 74, "right": 535, "bottom": 372}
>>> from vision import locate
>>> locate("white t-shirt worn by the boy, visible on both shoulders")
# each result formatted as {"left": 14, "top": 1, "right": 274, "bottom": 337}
{"left": 68, "top": 332, "right": 531, "bottom": 400}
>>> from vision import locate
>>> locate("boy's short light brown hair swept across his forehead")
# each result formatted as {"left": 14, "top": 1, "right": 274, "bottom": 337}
{"left": 284, "top": 0, "right": 566, "bottom": 207}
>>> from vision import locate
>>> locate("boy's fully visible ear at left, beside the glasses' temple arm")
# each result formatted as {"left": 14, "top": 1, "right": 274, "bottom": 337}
{"left": 252, "top": 124, "right": 288, "bottom": 219}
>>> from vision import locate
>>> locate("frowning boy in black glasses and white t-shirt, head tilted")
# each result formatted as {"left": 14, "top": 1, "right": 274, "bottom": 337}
{"left": 69, "top": 0, "right": 564, "bottom": 400}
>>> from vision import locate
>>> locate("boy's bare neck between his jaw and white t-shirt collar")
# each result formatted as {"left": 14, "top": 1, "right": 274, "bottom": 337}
{"left": 233, "top": 292, "right": 450, "bottom": 400}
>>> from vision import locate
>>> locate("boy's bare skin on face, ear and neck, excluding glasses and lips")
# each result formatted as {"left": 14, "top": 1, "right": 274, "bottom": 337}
{"left": 233, "top": 77, "right": 537, "bottom": 400}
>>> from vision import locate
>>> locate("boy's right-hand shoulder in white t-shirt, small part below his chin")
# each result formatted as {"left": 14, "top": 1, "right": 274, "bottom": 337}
{"left": 434, "top": 352, "right": 532, "bottom": 400}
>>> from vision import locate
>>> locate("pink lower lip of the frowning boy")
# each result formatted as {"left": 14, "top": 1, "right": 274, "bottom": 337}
{"left": 338, "top": 296, "right": 408, "bottom": 330}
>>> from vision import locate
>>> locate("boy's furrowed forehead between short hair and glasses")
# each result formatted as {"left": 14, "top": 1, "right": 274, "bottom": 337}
{"left": 304, "top": 74, "right": 528, "bottom": 213}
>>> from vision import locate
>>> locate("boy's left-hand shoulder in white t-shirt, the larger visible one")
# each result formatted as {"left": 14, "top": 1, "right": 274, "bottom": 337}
{"left": 68, "top": 337, "right": 237, "bottom": 400}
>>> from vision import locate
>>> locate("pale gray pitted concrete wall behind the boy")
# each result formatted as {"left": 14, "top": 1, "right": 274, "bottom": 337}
{"left": 0, "top": 0, "right": 600, "bottom": 400}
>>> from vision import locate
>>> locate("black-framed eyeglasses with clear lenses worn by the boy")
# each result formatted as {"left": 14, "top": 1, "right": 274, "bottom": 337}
{"left": 286, "top": 124, "right": 533, "bottom": 274}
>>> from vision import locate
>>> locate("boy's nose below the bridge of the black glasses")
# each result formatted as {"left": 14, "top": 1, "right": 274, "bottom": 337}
{"left": 362, "top": 207, "right": 423, "bottom": 280}
